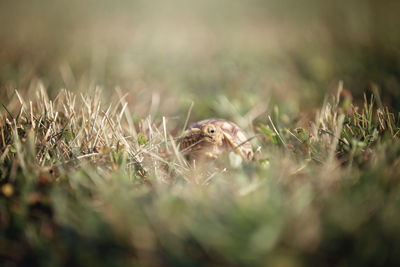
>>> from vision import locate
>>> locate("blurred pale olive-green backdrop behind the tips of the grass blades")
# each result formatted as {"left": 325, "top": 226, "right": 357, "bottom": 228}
{"left": 0, "top": 0, "right": 400, "bottom": 117}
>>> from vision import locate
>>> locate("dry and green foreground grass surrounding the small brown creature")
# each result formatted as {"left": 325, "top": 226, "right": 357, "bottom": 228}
{"left": 0, "top": 86, "right": 400, "bottom": 266}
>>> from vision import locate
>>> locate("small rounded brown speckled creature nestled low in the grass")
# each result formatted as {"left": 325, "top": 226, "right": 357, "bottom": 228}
{"left": 180, "top": 118, "right": 253, "bottom": 160}
